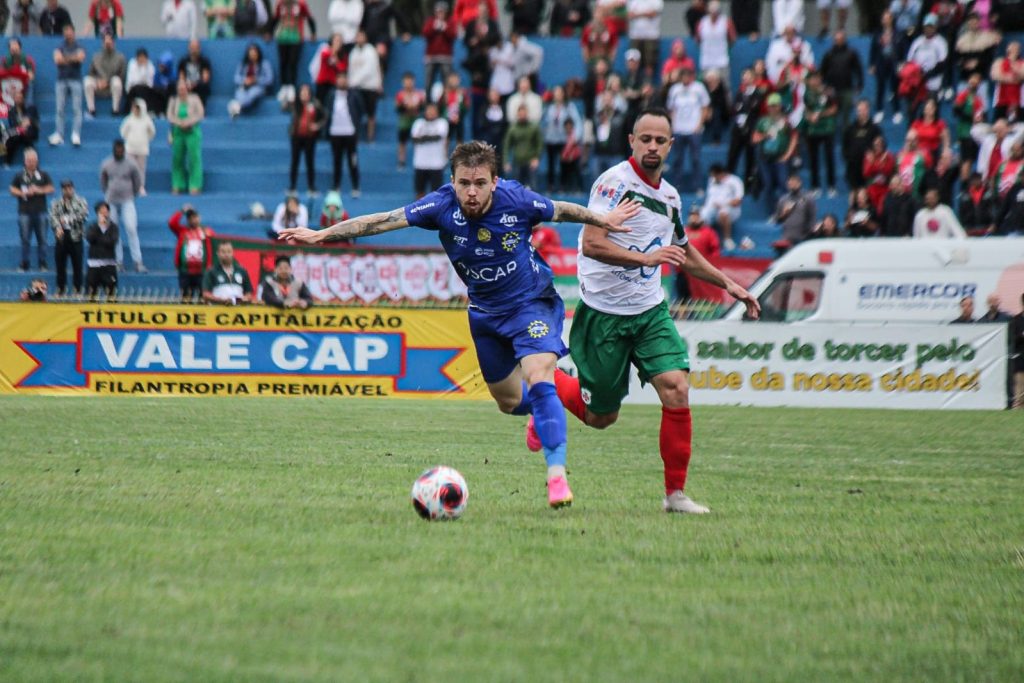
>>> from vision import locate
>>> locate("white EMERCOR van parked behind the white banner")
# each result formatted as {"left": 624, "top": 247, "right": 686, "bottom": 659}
{"left": 725, "top": 238, "right": 1024, "bottom": 323}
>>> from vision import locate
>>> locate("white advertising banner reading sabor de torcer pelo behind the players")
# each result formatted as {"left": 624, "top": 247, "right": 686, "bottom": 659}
{"left": 565, "top": 323, "right": 1008, "bottom": 410}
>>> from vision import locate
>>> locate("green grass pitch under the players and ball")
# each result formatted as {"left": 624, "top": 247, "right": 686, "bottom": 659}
{"left": 0, "top": 397, "right": 1024, "bottom": 681}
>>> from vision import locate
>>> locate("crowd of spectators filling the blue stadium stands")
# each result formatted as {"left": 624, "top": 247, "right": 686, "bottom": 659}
{"left": 6, "top": 0, "right": 1024, "bottom": 305}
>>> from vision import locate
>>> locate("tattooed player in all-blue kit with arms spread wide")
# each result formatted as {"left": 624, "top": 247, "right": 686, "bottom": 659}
{"left": 281, "top": 141, "right": 640, "bottom": 508}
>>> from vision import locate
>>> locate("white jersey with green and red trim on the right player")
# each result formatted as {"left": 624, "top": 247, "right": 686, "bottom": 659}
{"left": 577, "top": 157, "right": 686, "bottom": 315}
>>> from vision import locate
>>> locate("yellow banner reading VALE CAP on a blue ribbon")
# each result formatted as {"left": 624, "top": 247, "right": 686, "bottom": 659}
{"left": 0, "top": 303, "right": 488, "bottom": 399}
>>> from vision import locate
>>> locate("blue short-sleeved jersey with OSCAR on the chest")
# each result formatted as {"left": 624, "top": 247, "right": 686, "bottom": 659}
{"left": 406, "top": 179, "right": 555, "bottom": 312}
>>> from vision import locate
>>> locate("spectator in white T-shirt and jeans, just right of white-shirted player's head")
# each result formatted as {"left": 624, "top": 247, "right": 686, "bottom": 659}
{"left": 666, "top": 69, "right": 711, "bottom": 195}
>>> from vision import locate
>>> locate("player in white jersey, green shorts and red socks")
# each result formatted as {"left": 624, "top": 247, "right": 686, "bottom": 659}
{"left": 526, "top": 109, "right": 761, "bottom": 514}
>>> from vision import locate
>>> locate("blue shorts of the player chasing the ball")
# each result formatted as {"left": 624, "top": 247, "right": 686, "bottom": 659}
{"left": 469, "top": 294, "right": 569, "bottom": 384}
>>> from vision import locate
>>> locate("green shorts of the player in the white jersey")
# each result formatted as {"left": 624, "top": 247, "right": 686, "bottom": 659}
{"left": 569, "top": 301, "right": 690, "bottom": 415}
